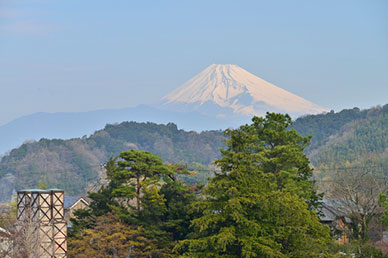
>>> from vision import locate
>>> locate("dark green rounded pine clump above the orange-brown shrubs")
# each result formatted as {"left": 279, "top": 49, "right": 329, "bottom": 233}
{"left": 70, "top": 150, "right": 199, "bottom": 257}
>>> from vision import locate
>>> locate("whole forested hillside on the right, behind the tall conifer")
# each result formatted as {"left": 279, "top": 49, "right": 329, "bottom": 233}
{"left": 293, "top": 105, "right": 388, "bottom": 182}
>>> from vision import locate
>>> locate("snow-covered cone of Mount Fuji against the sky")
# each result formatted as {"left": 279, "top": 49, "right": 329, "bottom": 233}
{"left": 162, "top": 64, "right": 327, "bottom": 117}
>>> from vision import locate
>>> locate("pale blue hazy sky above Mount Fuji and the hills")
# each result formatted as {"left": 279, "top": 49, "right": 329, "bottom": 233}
{"left": 0, "top": 0, "right": 388, "bottom": 125}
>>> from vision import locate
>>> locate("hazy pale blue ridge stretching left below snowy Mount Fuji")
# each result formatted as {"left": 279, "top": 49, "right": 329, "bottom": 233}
{"left": 0, "top": 105, "right": 249, "bottom": 155}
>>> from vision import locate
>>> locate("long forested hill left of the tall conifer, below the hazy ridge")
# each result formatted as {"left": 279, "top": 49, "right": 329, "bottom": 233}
{"left": 0, "top": 122, "right": 224, "bottom": 202}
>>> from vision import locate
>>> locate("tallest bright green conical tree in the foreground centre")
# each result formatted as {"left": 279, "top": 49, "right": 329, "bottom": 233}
{"left": 175, "top": 113, "right": 330, "bottom": 258}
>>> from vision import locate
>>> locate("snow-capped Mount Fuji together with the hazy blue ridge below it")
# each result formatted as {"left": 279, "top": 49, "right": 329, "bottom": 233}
{"left": 0, "top": 64, "right": 327, "bottom": 156}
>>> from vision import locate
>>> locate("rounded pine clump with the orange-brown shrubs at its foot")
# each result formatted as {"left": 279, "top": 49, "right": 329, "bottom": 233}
{"left": 69, "top": 150, "right": 199, "bottom": 257}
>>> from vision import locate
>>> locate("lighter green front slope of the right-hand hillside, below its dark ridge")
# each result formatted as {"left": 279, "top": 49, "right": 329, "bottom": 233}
{"left": 309, "top": 105, "right": 388, "bottom": 187}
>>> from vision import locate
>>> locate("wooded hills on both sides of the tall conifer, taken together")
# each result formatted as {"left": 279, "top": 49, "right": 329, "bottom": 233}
{"left": 0, "top": 105, "right": 388, "bottom": 202}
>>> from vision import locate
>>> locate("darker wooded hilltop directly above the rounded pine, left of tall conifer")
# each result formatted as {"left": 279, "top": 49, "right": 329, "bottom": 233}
{"left": 88, "top": 122, "right": 224, "bottom": 164}
